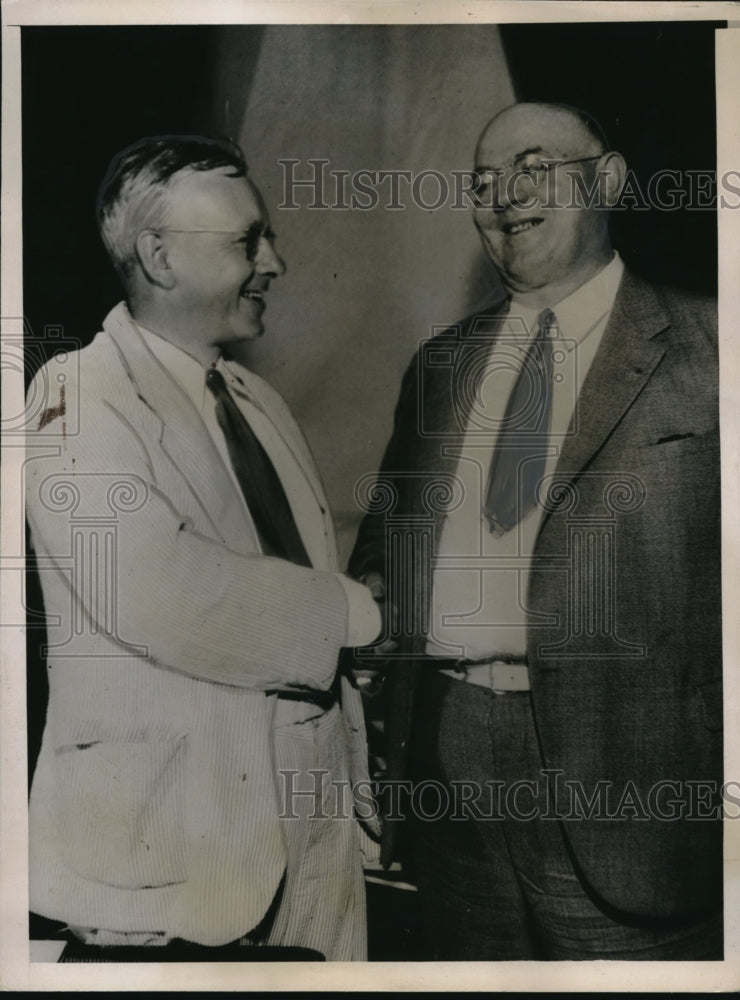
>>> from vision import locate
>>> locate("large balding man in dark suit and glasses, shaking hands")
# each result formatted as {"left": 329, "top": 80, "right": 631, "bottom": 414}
{"left": 350, "top": 104, "right": 722, "bottom": 960}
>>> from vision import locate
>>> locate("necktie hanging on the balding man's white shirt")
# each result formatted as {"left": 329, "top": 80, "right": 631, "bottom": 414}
{"left": 484, "top": 309, "right": 557, "bottom": 535}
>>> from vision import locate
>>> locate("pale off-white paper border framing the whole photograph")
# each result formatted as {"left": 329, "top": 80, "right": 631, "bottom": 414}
{"left": 0, "top": 0, "right": 740, "bottom": 992}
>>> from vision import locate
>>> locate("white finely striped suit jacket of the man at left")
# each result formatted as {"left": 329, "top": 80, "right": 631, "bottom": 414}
{"left": 25, "top": 304, "right": 379, "bottom": 945}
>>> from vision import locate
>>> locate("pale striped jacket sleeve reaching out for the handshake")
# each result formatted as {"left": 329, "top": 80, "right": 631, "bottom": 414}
{"left": 26, "top": 370, "right": 379, "bottom": 689}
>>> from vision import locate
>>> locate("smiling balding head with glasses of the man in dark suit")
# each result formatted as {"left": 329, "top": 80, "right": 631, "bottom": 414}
{"left": 475, "top": 103, "right": 625, "bottom": 306}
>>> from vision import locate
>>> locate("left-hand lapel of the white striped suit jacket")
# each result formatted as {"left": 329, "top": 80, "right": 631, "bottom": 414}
{"left": 104, "top": 307, "right": 256, "bottom": 550}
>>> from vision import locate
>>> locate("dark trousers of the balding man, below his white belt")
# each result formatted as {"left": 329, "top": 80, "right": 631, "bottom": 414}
{"left": 409, "top": 669, "right": 723, "bottom": 961}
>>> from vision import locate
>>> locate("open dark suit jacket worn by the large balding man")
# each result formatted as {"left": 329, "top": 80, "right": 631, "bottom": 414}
{"left": 350, "top": 272, "right": 722, "bottom": 917}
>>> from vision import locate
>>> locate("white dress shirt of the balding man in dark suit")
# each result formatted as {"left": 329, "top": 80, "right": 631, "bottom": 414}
{"left": 426, "top": 253, "right": 624, "bottom": 659}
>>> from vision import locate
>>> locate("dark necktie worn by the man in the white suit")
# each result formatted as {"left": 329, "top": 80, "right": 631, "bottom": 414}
{"left": 206, "top": 368, "right": 311, "bottom": 566}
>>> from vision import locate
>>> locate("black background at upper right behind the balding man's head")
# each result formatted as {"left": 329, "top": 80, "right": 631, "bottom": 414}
{"left": 501, "top": 22, "right": 721, "bottom": 294}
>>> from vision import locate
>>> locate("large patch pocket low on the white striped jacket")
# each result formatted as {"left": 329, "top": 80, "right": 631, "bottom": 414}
{"left": 55, "top": 737, "right": 186, "bottom": 889}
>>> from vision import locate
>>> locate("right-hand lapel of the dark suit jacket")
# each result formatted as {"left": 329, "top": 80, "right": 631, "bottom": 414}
{"left": 543, "top": 271, "right": 669, "bottom": 521}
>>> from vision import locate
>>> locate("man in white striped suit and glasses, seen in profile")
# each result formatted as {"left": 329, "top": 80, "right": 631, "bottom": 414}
{"left": 26, "top": 136, "right": 380, "bottom": 960}
